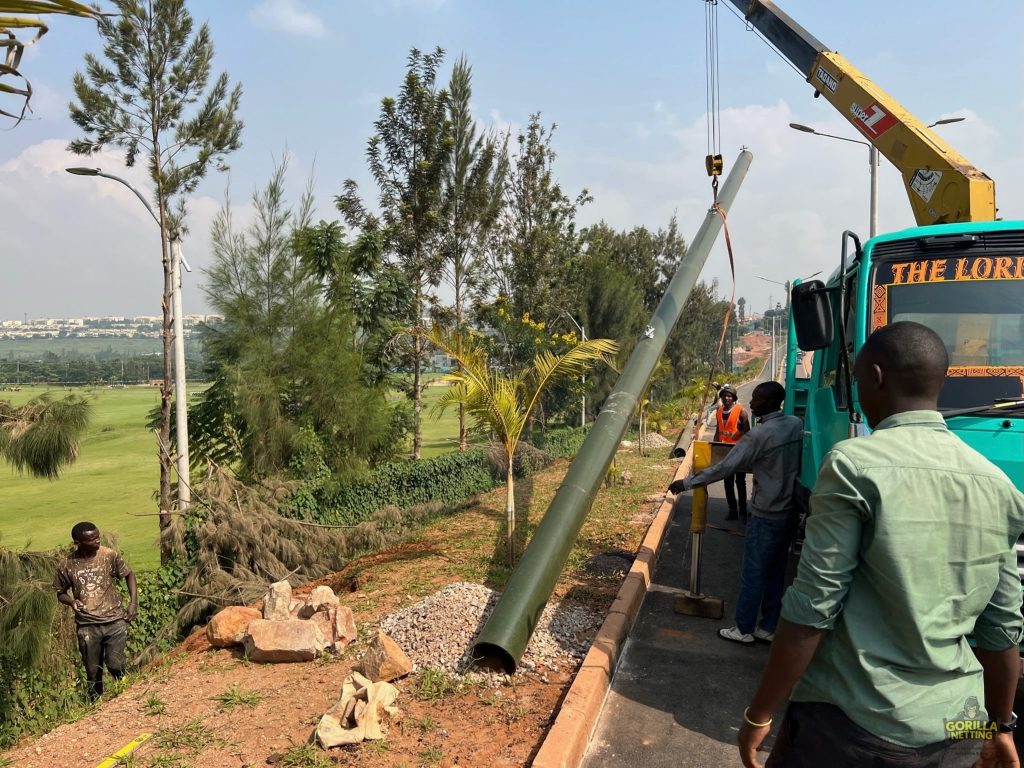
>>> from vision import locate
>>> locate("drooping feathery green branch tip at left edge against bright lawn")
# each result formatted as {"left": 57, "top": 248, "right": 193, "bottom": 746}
{"left": 0, "top": 394, "right": 91, "bottom": 479}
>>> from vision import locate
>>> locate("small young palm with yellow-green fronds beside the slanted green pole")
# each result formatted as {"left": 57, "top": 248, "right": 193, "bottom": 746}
{"left": 420, "top": 326, "right": 618, "bottom": 562}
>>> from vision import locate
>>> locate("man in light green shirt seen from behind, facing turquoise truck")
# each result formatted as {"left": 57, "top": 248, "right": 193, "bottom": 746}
{"left": 739, "top": 323, "right": 1024, "bottom": 768}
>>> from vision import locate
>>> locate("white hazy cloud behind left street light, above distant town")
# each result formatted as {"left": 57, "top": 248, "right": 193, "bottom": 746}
{"left": 0, "top": 139, "right": 226, "bottom": 318}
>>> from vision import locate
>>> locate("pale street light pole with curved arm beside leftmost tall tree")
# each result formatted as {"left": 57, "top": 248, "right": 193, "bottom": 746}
{"left": 66, "top": 168, "right": 191, "bottom": 513}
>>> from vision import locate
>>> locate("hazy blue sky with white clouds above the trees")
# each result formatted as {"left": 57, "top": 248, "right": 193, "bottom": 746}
{"left": 0, "top": 0, "right": 1024, "bottom": 319}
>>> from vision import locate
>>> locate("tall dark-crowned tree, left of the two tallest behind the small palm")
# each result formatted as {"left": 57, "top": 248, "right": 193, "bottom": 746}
{"left": 336, "top": 48, "right": 452, "bottom": 459}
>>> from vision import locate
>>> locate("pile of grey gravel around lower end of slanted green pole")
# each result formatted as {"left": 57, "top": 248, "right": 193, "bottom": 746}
{"left": 381, "top": 582, "right": 603, "bottom": 676}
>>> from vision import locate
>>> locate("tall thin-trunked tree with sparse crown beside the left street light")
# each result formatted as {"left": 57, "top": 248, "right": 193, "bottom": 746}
{"left": 69, "top": 0, "right": 242, "bottom": 559}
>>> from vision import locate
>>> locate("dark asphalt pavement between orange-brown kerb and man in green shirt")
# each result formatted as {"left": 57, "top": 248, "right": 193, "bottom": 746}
{"left": 584, "top": 483, "right": 771, "bottom": 768}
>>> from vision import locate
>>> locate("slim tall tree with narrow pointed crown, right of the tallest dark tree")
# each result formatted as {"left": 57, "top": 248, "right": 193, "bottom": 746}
{"left": 443, "top": 56, "right": 508, "bottom": 451}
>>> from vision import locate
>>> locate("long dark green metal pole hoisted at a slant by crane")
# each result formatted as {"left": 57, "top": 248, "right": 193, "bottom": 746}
{"left": 473, "top": 150, "right": 754, "bottom": 674}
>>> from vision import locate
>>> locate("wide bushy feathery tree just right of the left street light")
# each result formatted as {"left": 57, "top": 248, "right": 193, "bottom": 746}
{"left": 189, "top": 162, "right": 400, "bottom": 479}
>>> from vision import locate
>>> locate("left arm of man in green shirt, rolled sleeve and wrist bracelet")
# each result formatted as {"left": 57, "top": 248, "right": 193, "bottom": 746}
{"left": 739, "top": 452, "right": 867, "bottom": 768}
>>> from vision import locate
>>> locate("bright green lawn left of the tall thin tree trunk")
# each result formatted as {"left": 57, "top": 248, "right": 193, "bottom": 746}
{"left": 0, "top": 386, "right": 205, "bottom": 569}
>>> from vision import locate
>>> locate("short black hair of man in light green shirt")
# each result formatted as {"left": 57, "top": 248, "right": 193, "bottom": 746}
{"left": 858, "top": 321, "right": 949, "bottom": 396}
